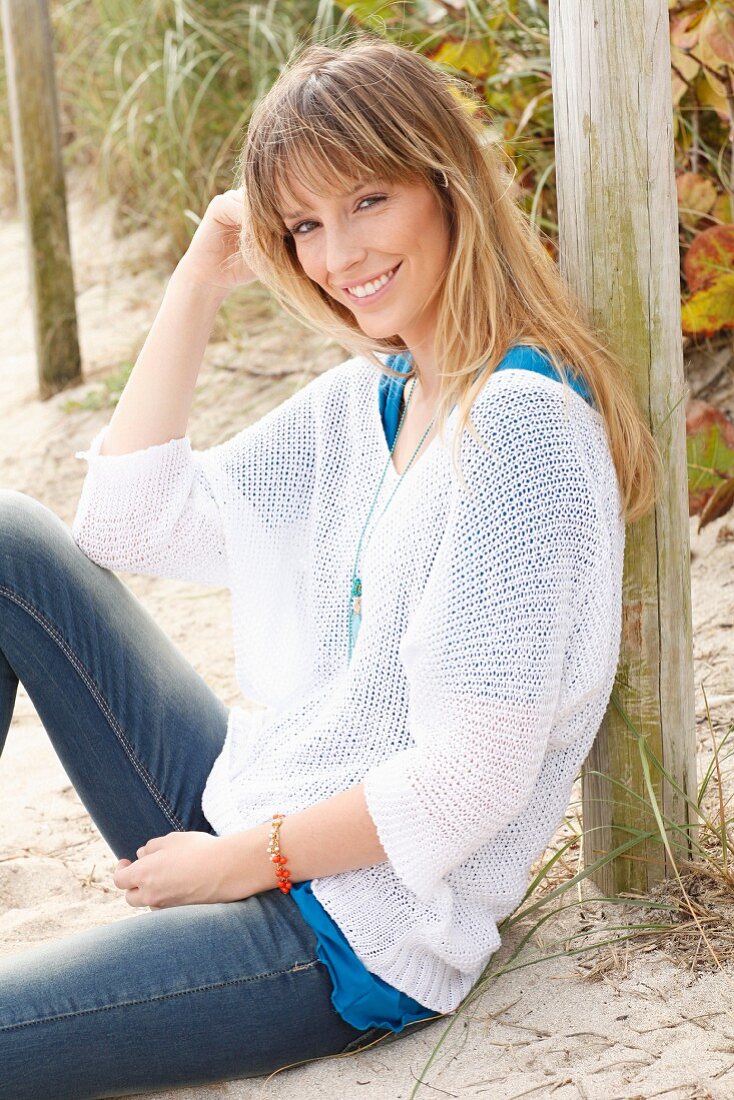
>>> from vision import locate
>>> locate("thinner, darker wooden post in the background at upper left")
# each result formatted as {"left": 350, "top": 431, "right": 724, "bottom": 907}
{"left": 1, "top": 0, "right": 81, "bottom": 398}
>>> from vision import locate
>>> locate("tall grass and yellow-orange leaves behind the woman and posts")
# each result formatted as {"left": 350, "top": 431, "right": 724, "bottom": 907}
{"left": 0, "top": 0, "right": 734, "bottom": 339}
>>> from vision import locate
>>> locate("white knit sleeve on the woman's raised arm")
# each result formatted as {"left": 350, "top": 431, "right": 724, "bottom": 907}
{"left": 72, "top": 375, "right": 325, "bottom": 586}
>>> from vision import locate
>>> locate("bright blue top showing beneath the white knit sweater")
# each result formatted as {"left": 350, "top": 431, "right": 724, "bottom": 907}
{"left": 291, "top": 344, "right": 593, "bottom": 1032}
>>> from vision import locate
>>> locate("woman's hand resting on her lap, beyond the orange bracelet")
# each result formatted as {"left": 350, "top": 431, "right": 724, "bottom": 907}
{"left": 112, "top": 833, "right": 247, "bottom": 909}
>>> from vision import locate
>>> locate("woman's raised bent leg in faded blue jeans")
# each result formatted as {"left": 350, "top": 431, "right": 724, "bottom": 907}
{"left": 0, "top": 492, "right": 228, "bottom": 859}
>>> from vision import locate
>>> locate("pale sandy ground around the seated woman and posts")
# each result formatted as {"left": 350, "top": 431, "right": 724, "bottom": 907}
{"left": 0, "top": 176, "right": 734, "bottom": 1100}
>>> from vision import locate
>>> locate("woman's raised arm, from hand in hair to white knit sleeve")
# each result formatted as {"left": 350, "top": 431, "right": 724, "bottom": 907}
{"left": 72, "top": 191, "right": 312, "bottom": 585}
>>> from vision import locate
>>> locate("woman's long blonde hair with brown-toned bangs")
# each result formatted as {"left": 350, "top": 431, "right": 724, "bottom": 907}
{"left": 238, "top": 39, "right": 662, "bottom": 523}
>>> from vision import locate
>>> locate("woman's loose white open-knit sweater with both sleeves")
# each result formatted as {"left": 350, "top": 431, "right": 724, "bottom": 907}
{"left": 73, "top": 358, "right": 625, "bottom": 1012}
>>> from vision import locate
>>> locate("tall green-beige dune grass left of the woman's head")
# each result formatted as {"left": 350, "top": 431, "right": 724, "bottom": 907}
{"left": 0, "top": 0, "right": 346, "bottom": 249}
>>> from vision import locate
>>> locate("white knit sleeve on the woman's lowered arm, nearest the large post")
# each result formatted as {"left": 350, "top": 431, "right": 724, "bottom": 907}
{"left": 364, "top": 384, "right": 599, "bottom": 901}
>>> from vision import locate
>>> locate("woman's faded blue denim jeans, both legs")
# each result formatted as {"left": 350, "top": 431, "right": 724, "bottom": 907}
{"left": 0, "top": 491, "right": 435, "bottom": 1100}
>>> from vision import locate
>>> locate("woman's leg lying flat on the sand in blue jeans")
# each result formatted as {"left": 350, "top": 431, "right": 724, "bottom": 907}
{"left": 0, "top": 890, "right": 394, "bottom": 1100}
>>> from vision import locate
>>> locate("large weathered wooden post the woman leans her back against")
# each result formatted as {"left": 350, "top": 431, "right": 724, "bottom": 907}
{"left": 549, "top": 0, "right": 697, "bottom": 895}
